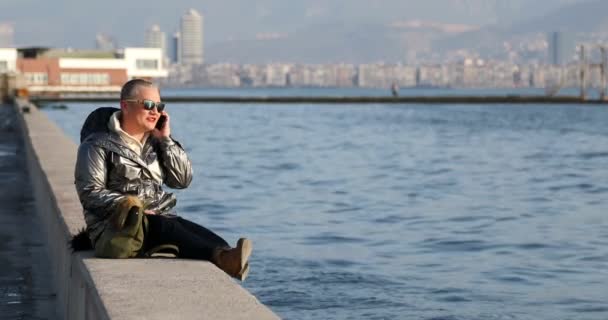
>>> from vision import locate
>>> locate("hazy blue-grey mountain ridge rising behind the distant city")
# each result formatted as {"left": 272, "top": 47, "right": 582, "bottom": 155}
{"left": 208, "top": 0, "right": 608, "bottom": 63}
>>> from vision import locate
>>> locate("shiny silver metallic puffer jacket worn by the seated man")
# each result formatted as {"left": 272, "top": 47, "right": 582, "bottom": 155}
{"left": 74, "top": 109, "right": 192, "bottom": 243}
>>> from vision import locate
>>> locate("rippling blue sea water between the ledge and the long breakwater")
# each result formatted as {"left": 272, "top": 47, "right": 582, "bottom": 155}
{"left": 48, "top": 99, "right": 608, "bottom": 319}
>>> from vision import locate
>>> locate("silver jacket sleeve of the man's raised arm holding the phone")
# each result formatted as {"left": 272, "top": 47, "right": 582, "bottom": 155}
{"left": 159, "top": 137, "right": 192, "bottom": 189}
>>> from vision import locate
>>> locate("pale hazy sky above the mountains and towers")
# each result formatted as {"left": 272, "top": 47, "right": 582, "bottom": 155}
{"left": 0, "top": 0, "right": 584, "bottom": 48}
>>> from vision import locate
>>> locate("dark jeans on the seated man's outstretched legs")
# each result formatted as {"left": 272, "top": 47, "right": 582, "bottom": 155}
{"left": 144, "top": 215, "right": 229, "bottom": 260}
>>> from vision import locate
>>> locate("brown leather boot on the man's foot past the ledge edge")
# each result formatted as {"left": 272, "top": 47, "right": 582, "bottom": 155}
{"left": 212, "top": 238, "right": 253, "bottom": 281}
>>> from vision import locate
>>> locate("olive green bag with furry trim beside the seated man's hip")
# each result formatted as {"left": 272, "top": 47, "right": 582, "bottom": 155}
{"left": 95, "top": 196, "right": 179, "bottom": 259}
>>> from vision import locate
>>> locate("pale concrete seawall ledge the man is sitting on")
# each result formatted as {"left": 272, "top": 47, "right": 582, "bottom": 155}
{"left": 14, "top": 100, "right": 278, "bottom": 319}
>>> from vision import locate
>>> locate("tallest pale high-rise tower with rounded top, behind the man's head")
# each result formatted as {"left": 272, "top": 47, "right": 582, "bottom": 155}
{"left": 180, "top": 9, "right": 203, "bottom": 65}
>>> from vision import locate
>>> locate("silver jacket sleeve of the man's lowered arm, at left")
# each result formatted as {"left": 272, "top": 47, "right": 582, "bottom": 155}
{"left": 74, "top": 142, "right": 124, "bottom": 218}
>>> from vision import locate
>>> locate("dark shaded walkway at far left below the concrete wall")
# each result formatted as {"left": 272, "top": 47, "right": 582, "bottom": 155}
{"left": 0, "top": 104, "right": 57, "bottom": 319}
